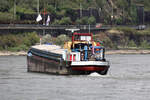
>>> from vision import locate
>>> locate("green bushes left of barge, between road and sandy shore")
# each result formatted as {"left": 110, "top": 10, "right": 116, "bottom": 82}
{"left": 0, "top": 32, "right": 39, "bottom": 51}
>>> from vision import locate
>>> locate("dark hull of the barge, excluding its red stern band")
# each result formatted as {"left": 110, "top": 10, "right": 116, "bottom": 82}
{"left": 27, "top": 55, "right": 108, "bottom": 75}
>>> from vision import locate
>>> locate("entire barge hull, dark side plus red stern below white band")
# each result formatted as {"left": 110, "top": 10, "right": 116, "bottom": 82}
{"left": 27, "top": 55, "right": 109, "bottom": 75}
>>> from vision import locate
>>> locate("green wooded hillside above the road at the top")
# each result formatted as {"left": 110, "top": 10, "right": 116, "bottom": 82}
{"left": 0, "top": 0, "right": 150, "bottom": 24}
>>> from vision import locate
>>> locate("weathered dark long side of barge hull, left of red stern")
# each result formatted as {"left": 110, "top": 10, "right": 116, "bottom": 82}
{"left": 27, "top": 55, "right": 68, "bottom": 75}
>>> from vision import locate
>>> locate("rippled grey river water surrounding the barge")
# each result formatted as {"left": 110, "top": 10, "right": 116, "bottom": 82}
{"left": 0, "top": 55, "right": 150, "bottom": 100}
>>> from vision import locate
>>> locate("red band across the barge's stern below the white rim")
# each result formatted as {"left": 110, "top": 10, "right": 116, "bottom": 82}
{"left": 72, "top": 66, "right": 106, "bottom": 71}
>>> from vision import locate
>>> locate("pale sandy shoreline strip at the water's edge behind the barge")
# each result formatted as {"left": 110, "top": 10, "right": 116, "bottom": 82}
{"left": 0, "top": 50, "right": 150, "bottom": 56}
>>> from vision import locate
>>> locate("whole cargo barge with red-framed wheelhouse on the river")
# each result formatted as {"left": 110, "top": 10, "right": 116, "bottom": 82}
{"left": 27, "top": 33, "right": 109, "bottom": 75}
